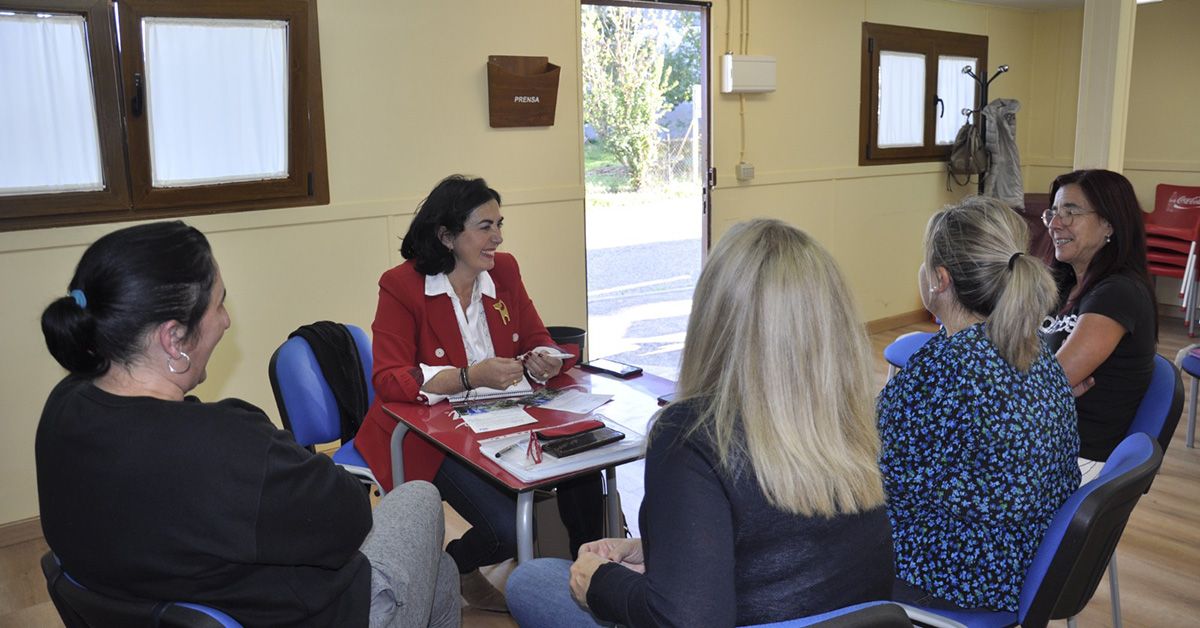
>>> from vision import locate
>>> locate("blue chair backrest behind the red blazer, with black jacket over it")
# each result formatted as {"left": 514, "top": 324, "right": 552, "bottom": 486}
{"left": 268, "top": 324, "right": 374, "bottom": 447}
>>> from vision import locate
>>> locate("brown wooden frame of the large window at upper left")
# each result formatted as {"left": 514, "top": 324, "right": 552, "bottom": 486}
{"left": 0, "top": 0, "right": 329, "bottom": 231}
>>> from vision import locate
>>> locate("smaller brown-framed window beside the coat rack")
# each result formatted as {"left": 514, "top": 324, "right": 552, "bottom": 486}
{"left": 858, "top": 22, "right": 988, "bottom": 166}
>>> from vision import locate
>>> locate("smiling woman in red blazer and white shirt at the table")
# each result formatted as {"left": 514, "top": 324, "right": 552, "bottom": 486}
{"left": 355, "top": 175, "right": 602, "bottom": 611}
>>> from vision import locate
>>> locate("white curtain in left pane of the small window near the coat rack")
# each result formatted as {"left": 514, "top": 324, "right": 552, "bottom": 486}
{"left": 876, "top": 50, "right": 925, "bottom": 148}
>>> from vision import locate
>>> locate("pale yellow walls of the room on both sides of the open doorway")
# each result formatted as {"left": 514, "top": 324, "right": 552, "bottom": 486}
{"left": 0, "top": 0, "right": 1200, "bottom": 524}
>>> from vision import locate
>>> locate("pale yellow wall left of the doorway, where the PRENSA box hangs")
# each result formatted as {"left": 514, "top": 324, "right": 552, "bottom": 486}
{"left": 0, "top": 0, "right": 587, "bottom": 524}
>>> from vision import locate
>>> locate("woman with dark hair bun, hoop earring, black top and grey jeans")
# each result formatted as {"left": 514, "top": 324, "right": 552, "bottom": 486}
{"left": 35, "top": 221, "right": 461, "bottom": 627}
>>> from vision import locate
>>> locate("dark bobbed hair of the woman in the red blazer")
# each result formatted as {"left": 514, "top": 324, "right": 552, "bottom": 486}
{"left": 400, "top": 174, "right": 500, "bottom": 275}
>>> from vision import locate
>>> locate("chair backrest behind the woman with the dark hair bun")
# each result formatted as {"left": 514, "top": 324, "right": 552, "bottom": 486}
{"left": 42, "top": 551, "right": 241, "bottom": 628}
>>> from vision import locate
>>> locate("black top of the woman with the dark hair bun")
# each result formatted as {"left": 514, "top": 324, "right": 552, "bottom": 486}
{"left": 35, "top": 376, "right": 371, "bottom": 627}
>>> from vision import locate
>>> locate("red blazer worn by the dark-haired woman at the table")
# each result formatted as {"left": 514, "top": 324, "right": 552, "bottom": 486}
{"left": 354, "top": 252, "right": 566, "bottom": 490}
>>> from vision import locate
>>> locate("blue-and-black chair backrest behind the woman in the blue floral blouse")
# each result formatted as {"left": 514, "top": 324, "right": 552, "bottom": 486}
{"left": 1018, "top": 432, "right": 1163, "bottom": 628}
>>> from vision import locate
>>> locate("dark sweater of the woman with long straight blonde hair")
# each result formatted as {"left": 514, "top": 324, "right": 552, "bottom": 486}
{"left": 588, "top": 405, "right": 895, "bottom": 628}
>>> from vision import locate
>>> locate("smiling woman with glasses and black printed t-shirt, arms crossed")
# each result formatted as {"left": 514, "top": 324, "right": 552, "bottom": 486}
{"left": 1042, "top": 169, "right": 1158, "bottom": 482}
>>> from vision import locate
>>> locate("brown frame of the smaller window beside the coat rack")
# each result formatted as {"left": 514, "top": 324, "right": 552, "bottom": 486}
{"left": 858, "top": 22, "right": 988, "bottom": 166}
